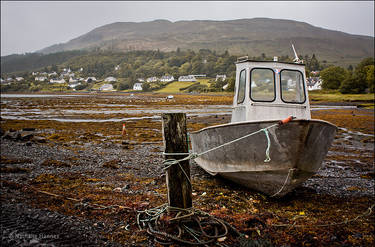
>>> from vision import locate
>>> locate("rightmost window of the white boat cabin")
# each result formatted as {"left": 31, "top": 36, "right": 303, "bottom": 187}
{"left": 280, "top": 70, "right": 306, "bottom": 104}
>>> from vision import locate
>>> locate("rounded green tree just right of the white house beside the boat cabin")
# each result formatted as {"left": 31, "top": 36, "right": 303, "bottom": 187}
{"left": 320, "top": 66, "right": 348, "bottom": 89}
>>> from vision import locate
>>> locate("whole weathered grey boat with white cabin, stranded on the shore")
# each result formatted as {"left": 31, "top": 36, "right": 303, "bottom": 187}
{"left": 190, "top": 54, "right": 337, "bottom": 197}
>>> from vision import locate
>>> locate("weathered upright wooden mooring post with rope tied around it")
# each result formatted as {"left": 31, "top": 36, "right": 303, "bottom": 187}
{"left": 162, "top": 113, "right": 192, "bottom": 208}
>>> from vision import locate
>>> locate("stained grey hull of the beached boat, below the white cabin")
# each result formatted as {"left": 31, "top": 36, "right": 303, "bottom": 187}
{"left": 190, "top": 120, "right": 337, "bottom": 196}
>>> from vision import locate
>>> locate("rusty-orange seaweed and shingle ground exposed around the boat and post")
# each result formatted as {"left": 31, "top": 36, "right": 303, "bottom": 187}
{"left": 0, "top": 94, "right": 375, "bottom": 246}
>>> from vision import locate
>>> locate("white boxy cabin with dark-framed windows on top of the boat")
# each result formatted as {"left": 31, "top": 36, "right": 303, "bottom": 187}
{"left": 231, "top": 59, "right": 311, "bottom": 122}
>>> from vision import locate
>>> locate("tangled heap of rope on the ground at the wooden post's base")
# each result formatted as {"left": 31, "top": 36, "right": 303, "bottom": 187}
{"left": 137, "top": 204, "right": 239, "bottom": 245}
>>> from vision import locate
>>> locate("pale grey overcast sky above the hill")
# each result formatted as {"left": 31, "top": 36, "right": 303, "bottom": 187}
{"left": 1, "top": 1, "right": 374, "bottom": 56}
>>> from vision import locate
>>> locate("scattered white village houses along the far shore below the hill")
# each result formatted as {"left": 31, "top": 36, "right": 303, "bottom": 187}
{"left": 1, "top": 65, "right": 322, "bottom": 92}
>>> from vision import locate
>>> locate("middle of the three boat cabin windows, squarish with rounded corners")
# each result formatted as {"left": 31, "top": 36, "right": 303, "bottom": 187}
{"left": 250, "top": 68, "right": 276, "bottom": 102}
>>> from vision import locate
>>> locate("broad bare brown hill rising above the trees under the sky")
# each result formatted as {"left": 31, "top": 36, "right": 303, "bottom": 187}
{"left": 39, "top": 18, "right": 374, "bottom": 65}
